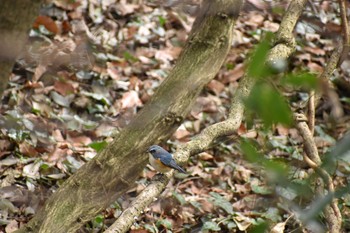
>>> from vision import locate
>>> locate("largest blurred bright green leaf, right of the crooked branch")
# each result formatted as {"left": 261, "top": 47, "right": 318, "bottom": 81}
{"left": 246, "top": 83, "right": 293, "bottom": 127}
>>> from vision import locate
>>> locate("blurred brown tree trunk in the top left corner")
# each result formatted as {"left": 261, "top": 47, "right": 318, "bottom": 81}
{"left": 0, "top": 0, "right": 42, "bottom": 97}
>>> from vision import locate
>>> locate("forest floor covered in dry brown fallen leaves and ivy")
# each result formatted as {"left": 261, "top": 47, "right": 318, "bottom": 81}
{"left": 0, "top": 0, "right": 350, "bottom": 233}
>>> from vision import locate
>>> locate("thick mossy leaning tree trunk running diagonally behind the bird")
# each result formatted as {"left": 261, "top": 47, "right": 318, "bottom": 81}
{"left": 17, "top": 0, "right": 243, "bottom": 233}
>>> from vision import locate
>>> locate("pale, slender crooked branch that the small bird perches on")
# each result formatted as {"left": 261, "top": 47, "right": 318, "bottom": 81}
{"left": 105, "top": 0, "right": 307, "bottom": 233}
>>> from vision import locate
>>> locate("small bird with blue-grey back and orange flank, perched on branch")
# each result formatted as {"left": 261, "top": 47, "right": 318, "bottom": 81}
{"left": 147, "top": 145, "right": 186, "bottom": 173}
